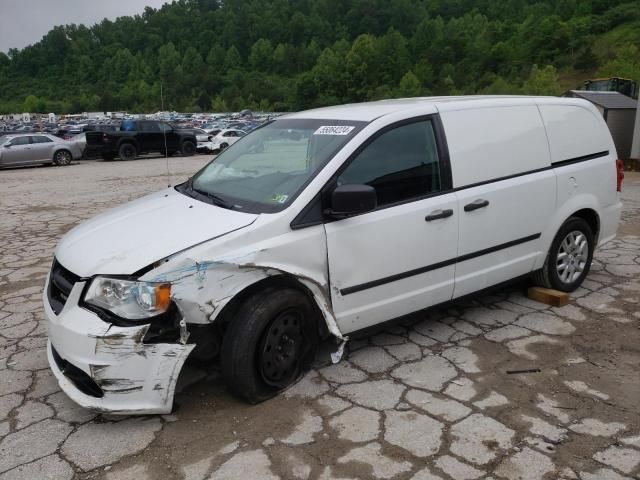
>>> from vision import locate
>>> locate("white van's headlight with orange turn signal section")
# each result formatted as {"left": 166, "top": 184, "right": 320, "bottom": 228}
{"left": 84, "top": 277, "right": 171, "bottom": 320}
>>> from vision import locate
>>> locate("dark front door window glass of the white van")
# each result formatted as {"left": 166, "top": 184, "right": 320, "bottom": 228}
{"left": 338, "top": 120, "right": 441, "bottom": 206}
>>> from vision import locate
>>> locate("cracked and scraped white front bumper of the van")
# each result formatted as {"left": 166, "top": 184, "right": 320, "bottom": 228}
{"left": 44, "top": 282, "right": 195, "bottom": 414}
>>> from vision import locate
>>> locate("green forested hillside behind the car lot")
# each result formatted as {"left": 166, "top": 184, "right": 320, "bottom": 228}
{"left": 0, "top": 0, "right": 640, "bottom": 113}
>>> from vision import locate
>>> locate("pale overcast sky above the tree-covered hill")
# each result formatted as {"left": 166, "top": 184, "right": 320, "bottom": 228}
{"left": 0, "top": 0, "right": 167, "bottom": 52}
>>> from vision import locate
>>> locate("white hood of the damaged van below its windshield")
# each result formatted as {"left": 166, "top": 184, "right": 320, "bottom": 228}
{"left": 55, "top": 188, "right": 257, "bottom": 277}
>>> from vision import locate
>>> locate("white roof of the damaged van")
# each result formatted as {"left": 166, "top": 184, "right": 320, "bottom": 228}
{"left": 282, "top": 95, "right": 588, "bottom": 122}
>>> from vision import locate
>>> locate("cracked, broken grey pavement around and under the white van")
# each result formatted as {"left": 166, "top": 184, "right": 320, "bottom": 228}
{"left": 0, "top": 156, "right": 640, "bottom": 480}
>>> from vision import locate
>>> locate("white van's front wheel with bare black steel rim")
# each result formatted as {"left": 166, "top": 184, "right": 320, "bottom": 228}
{"left": 221, "top": 288, "right": 318, "bottom": 403}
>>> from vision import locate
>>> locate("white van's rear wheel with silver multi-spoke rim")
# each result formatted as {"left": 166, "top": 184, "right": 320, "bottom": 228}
{"left": 534, "top": 217, "right": 595, "bottom": 292}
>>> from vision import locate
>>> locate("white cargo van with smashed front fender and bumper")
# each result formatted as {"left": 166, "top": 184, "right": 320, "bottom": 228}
{"left": 44, "top": 97, "right": 622, "bottom": 413}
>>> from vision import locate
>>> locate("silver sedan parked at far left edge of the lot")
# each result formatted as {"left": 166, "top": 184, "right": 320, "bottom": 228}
{"left": 0, "top": 133, "right": 82, "bottom": 168}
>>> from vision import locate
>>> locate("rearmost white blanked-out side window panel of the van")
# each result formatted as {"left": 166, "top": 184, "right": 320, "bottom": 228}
{"left": 540, "top": 105, "right": 611, "bottom": 163}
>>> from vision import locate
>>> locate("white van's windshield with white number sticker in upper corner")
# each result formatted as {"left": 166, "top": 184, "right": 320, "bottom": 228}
{"left": 185, "top": 119, "right": 365, "bottom": 213}
